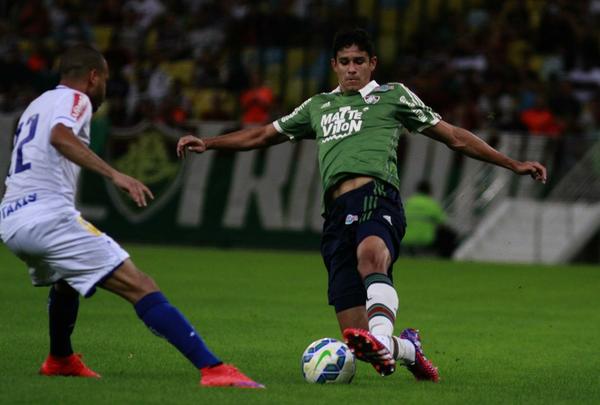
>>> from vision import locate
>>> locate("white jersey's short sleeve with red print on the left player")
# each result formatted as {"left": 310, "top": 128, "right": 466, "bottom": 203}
{"left": 50, "top": 91, "right": 92, "bottom": 141}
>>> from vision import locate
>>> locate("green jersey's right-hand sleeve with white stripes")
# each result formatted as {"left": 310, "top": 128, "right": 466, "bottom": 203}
{"left": 397, "top": 84, "right": 442, "bottom": 132}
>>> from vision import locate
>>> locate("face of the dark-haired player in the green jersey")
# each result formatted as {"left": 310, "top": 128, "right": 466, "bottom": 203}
{"left": 331, "top": 45, "right": 377, "bottom": 91}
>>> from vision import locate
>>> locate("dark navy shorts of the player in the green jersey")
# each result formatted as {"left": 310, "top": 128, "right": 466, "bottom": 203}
{"left": 321, "top": 180, "right": 406, "bottom": 312}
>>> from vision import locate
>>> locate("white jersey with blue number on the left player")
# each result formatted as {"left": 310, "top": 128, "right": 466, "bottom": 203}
{"left": 0, "top": 86, "right": 92, "bottom": 241}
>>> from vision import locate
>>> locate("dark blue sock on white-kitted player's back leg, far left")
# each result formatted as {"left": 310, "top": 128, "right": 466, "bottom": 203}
{"left": 48, "top": 287, "right": 79, "bottom": 357}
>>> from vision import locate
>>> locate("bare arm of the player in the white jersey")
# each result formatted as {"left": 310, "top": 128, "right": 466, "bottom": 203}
{"left": 50, "top": 124, "right": 154, "bottom": 207}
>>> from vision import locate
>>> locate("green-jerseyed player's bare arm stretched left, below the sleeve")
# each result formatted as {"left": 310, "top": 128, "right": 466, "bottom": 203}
{"left": 177, "top": 124, "right": 288, "bottom": 158}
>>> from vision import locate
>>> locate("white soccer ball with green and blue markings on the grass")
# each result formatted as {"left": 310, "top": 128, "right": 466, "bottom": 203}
{"left": 302, "top": 338, "right": 356, "bottom": 384}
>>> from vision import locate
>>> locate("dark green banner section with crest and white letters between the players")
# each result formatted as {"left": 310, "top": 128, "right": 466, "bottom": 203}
{"left": 77, "top": 123, "right": 322, "bottom": 249}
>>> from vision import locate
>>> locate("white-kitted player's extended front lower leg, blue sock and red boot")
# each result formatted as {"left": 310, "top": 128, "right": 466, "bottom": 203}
{"left": 101, "top": 259, "right": 262, "bottom": 388}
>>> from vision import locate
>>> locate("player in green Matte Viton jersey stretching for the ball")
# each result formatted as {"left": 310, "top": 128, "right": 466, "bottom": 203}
{"left": 177, "top": 29, "right": 546, "bottom": 381}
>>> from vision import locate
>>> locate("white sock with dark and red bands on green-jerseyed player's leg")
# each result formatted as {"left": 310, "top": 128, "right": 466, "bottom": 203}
{"left": 365, "top": 273, "right": 398, "bottom": 336}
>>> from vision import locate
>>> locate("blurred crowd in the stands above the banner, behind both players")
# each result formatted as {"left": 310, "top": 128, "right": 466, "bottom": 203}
{"left": 0, "top": 0, "right": 600, "bottom": 138}
